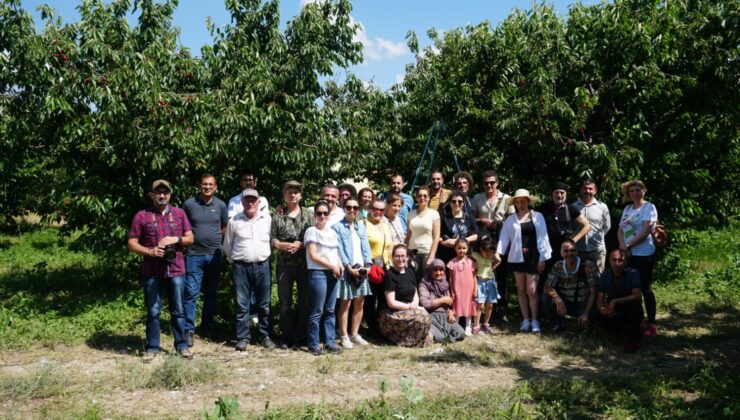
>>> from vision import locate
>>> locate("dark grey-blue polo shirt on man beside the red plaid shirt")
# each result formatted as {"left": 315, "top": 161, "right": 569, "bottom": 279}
{"left": 182, "top": 195, "right": 229, "bottom": 255}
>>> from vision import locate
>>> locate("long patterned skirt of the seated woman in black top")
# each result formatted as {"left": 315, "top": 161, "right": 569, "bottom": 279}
{"left": 380, "top": 308, "right": 433, "bottom": 347}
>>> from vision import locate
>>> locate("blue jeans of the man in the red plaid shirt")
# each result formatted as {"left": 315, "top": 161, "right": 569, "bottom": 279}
{"left": 141, "top": 276, "right": 188, "bottom": 352}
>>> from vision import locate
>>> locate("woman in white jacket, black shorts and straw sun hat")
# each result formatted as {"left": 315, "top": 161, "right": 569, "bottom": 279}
{"left": 494, "top": 189, "right": 552, "bottom": 334}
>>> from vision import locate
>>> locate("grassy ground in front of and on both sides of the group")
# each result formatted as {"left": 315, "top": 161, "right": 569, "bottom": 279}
{"left": 0, "top": 221, "right": 740, "bottom": 419}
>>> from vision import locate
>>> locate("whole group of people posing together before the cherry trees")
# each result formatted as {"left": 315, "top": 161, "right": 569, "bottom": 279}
{"left": 128, "top": 170, "right": 657, "bottom": 358}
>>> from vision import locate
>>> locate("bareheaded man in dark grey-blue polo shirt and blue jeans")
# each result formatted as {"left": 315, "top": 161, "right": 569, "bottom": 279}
{"left": 182, "top": 174, "right": 229, "bottom": 347}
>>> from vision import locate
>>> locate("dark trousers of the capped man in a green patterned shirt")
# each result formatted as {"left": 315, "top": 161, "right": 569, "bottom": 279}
{"left": 275, "top": 264, "right": 308, "bottom": 344}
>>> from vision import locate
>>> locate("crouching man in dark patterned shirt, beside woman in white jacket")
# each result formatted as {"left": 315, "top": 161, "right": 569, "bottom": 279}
{"left": 544, "top": 239, "right": 599, "bottom": 332}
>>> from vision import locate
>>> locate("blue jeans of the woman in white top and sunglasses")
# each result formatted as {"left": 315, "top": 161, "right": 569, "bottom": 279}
{"left": 308, "top": 270, "right": 339, "bottom": 348}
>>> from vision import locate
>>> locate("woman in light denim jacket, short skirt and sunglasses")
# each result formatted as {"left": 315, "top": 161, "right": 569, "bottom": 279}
{"left": 332, "top": 198, "right": 372, "bottom": 349}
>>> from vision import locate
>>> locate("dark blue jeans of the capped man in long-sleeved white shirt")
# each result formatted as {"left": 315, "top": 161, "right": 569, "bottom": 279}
{"left": 232, "top": 259, "right": 270, "bottom": 341}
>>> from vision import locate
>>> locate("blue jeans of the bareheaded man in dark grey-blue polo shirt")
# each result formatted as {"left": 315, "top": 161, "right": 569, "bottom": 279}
{"left": 183, "top": 249, "right": 223, "bottom": 331}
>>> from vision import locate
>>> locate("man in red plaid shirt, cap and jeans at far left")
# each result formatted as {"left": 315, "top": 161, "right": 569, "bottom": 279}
{"left": 128, "top": 179, "right": 193, "bottom": 359}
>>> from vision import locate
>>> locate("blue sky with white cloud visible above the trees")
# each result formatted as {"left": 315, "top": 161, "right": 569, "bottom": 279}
{"left": 21, "top": 0, "right": 600, "bottom": 89}
